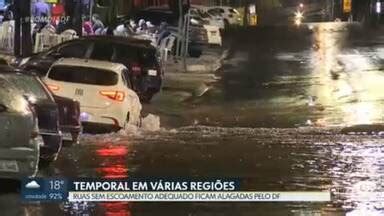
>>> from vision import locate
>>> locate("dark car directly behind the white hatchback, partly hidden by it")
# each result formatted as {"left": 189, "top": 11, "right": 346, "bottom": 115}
{"left": 20, "top": 36, "right": 163, "bottom": 102}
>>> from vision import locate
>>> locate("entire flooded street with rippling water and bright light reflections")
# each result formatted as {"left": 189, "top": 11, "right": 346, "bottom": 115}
{"left": 0, "top": 23, "right": 384, "bottom": 216}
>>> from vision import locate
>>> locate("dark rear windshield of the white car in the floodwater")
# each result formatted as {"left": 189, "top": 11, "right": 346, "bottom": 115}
{"left": 48, "top": 66, "right": 118, "bottom": 86}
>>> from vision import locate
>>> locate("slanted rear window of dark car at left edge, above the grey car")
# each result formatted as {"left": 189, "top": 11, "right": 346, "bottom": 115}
{"left": 2, "top": 74, "right": 49, "bottom": 100}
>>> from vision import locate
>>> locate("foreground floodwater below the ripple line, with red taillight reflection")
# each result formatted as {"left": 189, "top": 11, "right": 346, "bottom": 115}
{"left": 22, "top": 126, "right": 384, "bottom": 215}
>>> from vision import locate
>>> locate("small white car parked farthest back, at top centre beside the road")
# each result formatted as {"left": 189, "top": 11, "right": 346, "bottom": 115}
{"left": 206, "top": 6, "right": 242, "bottom": 26}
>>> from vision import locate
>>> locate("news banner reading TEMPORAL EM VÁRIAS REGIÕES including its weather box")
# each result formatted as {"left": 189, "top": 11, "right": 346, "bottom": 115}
{"left": 21, "top": 178, "right": 331, "bottom": 202}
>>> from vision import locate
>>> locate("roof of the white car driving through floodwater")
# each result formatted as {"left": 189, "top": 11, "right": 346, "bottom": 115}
{"left": 52, "top": 58, "right": 126, "bottom": 73}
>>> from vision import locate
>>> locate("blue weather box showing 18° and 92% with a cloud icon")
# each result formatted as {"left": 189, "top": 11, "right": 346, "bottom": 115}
{"left": 21, "top": 178, "right": 68, "bottom": 202}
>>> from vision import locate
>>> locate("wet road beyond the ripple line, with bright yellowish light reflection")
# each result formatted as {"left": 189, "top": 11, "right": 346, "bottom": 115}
{"left": 154, "top": 23, "right": 384, "bottom": 127}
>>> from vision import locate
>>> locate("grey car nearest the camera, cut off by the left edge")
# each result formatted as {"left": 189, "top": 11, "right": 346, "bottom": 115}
{"left": 0, "top": 79, "right": 40, "bottom": 179}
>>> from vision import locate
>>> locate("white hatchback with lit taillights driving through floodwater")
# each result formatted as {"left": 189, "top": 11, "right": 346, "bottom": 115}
{"left": 44, "top": 58, "right": 142, "bottom": 130}
